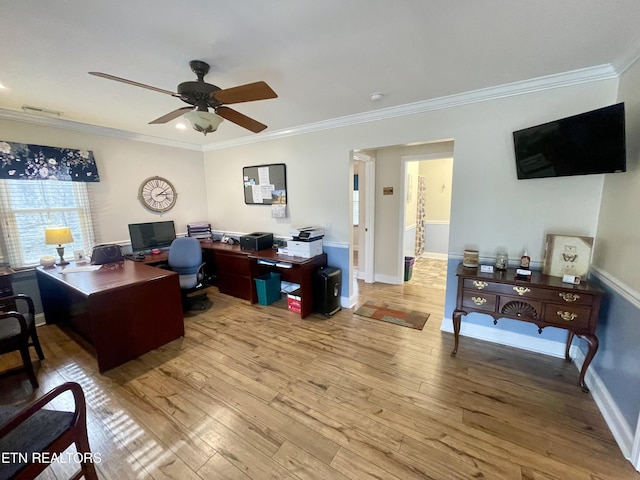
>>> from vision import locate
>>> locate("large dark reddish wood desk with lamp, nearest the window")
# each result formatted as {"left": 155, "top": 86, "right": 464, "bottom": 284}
{"left": 36, "top": 261, "right": 184, "bottom": 372}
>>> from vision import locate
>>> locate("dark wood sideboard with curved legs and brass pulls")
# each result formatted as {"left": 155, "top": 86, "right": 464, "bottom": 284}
{"left": 451, "top": 264, "right": 604, "bottom": 392}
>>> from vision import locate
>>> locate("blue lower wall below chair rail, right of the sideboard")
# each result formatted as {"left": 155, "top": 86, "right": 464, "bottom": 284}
{"left": 579, "top": 276, "right": 640, "bottom": 430}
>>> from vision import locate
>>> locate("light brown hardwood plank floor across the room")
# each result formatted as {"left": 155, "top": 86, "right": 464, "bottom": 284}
{"left": 0, "top": 262, "right": 640, "bottom": 480}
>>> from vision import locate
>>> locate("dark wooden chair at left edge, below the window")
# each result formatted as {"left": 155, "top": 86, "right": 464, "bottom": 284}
{"left": 0, "top": 293, "right": 44, "bottom": 389}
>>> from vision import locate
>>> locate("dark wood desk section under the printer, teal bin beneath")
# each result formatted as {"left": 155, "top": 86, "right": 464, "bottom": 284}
{"left": 249, "top": 249, "right": 327, "bottom": 318}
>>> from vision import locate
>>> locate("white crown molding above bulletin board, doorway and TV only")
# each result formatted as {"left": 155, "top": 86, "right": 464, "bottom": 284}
{"left": 203, "top": 64, "right": 618, "bottom": 152}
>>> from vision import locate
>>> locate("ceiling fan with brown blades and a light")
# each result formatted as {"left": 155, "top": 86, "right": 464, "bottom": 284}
{"left": 89, "top": 60, "right": 278, "bottom": 135}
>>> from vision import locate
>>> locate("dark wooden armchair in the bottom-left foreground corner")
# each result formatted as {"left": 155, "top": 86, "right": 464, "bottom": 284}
{"left": 0, "top": 382, "right": 98, "bottom": 480}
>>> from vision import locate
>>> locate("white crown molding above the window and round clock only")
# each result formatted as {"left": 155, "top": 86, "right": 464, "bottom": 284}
{"left": 0, "top": 108, "right": 202, "bottom": 152}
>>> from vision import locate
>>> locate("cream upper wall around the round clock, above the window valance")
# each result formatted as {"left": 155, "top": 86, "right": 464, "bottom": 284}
{"left": 0, "top": 119, "right": 207, "bottom": 243}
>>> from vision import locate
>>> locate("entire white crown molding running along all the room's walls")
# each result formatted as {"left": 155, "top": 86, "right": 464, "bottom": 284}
{"left": 0, "top": 62, "right": 620, "bottom": 152}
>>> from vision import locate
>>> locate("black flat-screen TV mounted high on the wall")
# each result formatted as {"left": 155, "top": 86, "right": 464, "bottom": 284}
{"left": 513, "top": 103, "right": 627, "bottom": 179}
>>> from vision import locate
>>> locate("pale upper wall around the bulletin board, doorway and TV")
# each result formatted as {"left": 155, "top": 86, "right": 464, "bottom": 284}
{"left": 205, "top": 79, "right": 617, "bottom": 276}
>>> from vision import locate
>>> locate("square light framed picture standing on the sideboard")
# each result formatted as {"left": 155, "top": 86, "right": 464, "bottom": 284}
{"left": 542, "top": 234, "right": 593, "bottom": 278}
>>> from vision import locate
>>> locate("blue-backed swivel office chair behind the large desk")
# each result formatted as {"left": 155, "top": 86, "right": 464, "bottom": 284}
{"left": 167, "top": 237, "right": 210, "bottom": 310}
